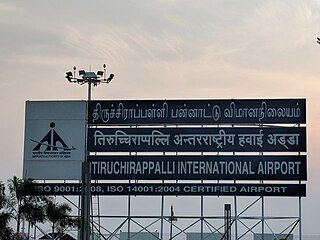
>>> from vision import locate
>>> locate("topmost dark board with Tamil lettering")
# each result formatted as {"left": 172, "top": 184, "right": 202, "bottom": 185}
{"left": 88, "top": 99, "right": 306, "bottom": 125}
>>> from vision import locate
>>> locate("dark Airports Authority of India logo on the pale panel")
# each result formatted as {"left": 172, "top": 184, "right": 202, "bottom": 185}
{"left": 30, "top": 122, "right": 77, "bottom": 159}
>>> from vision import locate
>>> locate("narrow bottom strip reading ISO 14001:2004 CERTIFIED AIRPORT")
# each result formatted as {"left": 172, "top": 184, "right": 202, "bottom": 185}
{"left": 33, "top": 183, "right": 306, "bottom": 197}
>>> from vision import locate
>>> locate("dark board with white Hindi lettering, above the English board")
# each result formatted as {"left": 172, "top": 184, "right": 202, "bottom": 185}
{"left": 88, "top": 127, "right": 306, "bottom": 152}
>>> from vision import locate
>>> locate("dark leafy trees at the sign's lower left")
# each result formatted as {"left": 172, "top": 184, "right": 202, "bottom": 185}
{"left": 0, "top": 176, "right": 80, "bottom": 240}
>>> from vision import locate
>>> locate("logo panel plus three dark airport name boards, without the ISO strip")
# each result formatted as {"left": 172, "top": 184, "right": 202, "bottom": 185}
{"left": 23, "top": 99, "right": 307, "bottom": 188}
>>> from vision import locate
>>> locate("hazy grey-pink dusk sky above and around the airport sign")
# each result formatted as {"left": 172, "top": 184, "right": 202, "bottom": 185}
{"left": 0, "top": 0, "right": 320, "bottom": 237}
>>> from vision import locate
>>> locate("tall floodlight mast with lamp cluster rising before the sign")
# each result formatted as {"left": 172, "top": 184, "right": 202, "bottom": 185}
{"left": 66, "top": 64, "right": 114, "bottom": 240}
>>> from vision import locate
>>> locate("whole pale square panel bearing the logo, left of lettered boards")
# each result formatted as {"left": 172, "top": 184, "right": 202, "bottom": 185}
{"left": 23, "top": 101, "right": 86, "bottom": 180}
